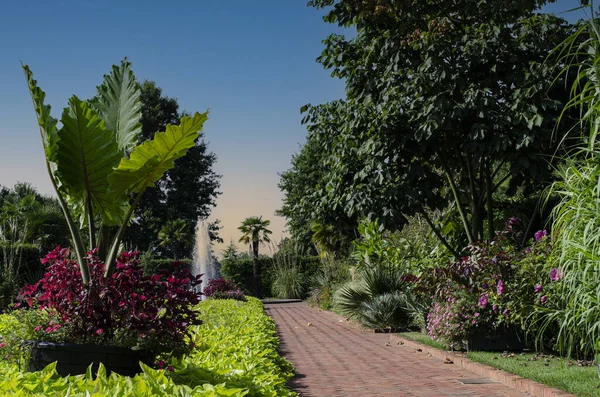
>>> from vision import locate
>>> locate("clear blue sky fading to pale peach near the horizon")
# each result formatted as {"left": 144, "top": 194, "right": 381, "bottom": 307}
{"left": 0, "top": 0, "right": 578, "bottom": 254}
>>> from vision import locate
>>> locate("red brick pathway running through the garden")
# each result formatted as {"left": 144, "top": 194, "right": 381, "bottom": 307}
{"left": 265, "top": 303, "right": 529, "bottom": 397}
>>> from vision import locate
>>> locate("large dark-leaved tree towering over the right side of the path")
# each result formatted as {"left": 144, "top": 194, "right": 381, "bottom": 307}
{"left": 296, "top": 0, "right": 574, "bottom": 248}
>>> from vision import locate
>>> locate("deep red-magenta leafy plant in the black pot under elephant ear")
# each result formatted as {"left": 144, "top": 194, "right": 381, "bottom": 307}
{"left": 19, "top": 247, "right": 201, "bottom": 355}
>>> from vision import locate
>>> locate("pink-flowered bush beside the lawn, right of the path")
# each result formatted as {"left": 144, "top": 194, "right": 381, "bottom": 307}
{"left": 419, "top": 218, "right": 561, "bottom": 346}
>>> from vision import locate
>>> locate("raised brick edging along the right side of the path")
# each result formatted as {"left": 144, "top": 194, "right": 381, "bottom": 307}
{"left": 313, "top": 308, "right": 577, "bottom": 397}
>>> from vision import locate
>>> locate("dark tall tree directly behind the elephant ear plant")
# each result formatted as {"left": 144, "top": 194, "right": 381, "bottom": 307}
{"left": 126, "top": 81, "right": 221, "bottom": 256}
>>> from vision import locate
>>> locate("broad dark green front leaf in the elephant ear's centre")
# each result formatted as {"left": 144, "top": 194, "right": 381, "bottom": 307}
{"left": 56, "top": 96, "right": 124, "bottom": 225}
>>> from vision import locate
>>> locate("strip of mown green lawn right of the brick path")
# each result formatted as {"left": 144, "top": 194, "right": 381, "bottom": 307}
{"left": 400, "top": 332, "right": 600, "bottom": 397}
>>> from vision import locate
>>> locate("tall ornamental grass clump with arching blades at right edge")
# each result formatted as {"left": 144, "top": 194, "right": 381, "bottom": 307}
{"left": 536, "top": 13, "right": 600, "bottom": 358}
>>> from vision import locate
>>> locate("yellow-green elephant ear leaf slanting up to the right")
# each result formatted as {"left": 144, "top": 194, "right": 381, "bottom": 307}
{"left": 109, "top": 112, "right": 208, "bottom": 195}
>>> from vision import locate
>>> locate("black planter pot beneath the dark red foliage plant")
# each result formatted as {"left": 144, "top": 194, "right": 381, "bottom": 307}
{"left": 25, "top": 341, "right": 154, "bottom": 376}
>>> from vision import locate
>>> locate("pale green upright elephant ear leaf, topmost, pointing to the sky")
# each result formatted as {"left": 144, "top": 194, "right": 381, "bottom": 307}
{"left": 92, "top": 59, "right": 142, "bottom": 154}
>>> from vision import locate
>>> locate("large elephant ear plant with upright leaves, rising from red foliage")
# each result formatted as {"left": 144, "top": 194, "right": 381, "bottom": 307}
{"left": 23, "top": 59, "right": 208, "bottom": 285}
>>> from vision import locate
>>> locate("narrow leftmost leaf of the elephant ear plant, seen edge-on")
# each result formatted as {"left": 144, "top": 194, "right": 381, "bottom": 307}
{"left": 22, "top": 65, "right": 58, "bottom": 163}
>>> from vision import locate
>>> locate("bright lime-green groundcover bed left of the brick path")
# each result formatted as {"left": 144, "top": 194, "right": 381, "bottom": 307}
{"left": 0, "top": 298, "right": 296, "bottom": 397}
